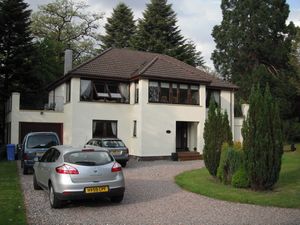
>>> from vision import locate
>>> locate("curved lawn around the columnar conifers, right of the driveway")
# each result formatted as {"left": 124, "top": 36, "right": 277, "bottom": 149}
{"left": 175, "top": 144, "right": 300, "bottom": 208}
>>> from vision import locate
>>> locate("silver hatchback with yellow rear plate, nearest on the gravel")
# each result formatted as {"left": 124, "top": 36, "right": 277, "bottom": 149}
{"left": 33, "top": 145, "right": 125, "bottom": 208}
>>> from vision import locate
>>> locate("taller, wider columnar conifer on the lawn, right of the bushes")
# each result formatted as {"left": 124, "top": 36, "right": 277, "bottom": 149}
{"left": 242, "top": 86, "right": 283, "bottom": 190}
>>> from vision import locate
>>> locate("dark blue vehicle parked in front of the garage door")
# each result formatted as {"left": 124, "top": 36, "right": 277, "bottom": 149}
{"left": 19, "top": 132, "right": 60, "bottom": 174}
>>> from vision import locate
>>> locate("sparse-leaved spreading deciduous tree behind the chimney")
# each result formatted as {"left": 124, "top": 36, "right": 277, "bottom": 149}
{"left": 31, "top": 0, "right": 102, "bottom": 62}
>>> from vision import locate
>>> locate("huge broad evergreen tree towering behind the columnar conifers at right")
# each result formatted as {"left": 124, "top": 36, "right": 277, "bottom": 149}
{"left": 212, "top": 0, "right": 298, "bottom": 139}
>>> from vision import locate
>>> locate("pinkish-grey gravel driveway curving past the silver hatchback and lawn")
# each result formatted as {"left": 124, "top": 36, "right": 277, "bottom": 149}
{"left": 20, "top": 160, "right": 300, "bottom": 225}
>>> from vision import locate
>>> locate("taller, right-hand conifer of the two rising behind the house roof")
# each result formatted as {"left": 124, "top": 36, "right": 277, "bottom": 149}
{"left": 133, "top": 0, "right": 203, "bottom": 66}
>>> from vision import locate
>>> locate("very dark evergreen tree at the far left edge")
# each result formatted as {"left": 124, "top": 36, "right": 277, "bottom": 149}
{"left": 0, "top": 0, "right": 34, "bottom": 142}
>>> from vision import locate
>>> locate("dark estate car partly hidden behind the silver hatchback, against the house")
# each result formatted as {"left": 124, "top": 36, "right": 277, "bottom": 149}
{"left": 86, "top": 138, "right": 129, "bottom": 167}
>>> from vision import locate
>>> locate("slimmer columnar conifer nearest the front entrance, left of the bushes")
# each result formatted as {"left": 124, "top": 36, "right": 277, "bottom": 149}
{"left": 203, "top": 100, "right": 232, "bottom": 176}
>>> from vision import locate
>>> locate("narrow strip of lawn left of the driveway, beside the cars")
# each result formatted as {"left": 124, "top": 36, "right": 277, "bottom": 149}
{"left": 0, "top": 161, "right": 27, "bottom": 225}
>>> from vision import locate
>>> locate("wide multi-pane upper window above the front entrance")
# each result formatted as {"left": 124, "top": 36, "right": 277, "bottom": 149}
{"left": 149, "top": 81, "right": 199, "bottom": 105}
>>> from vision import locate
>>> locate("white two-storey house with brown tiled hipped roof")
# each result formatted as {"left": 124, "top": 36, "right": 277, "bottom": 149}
{"left": 6, "top": 48, "right": 240, "bottom": 158}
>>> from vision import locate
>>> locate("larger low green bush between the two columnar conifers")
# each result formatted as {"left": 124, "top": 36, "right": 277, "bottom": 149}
{"left": 217, "top": 143, "right": 243, "bottom": 184}
